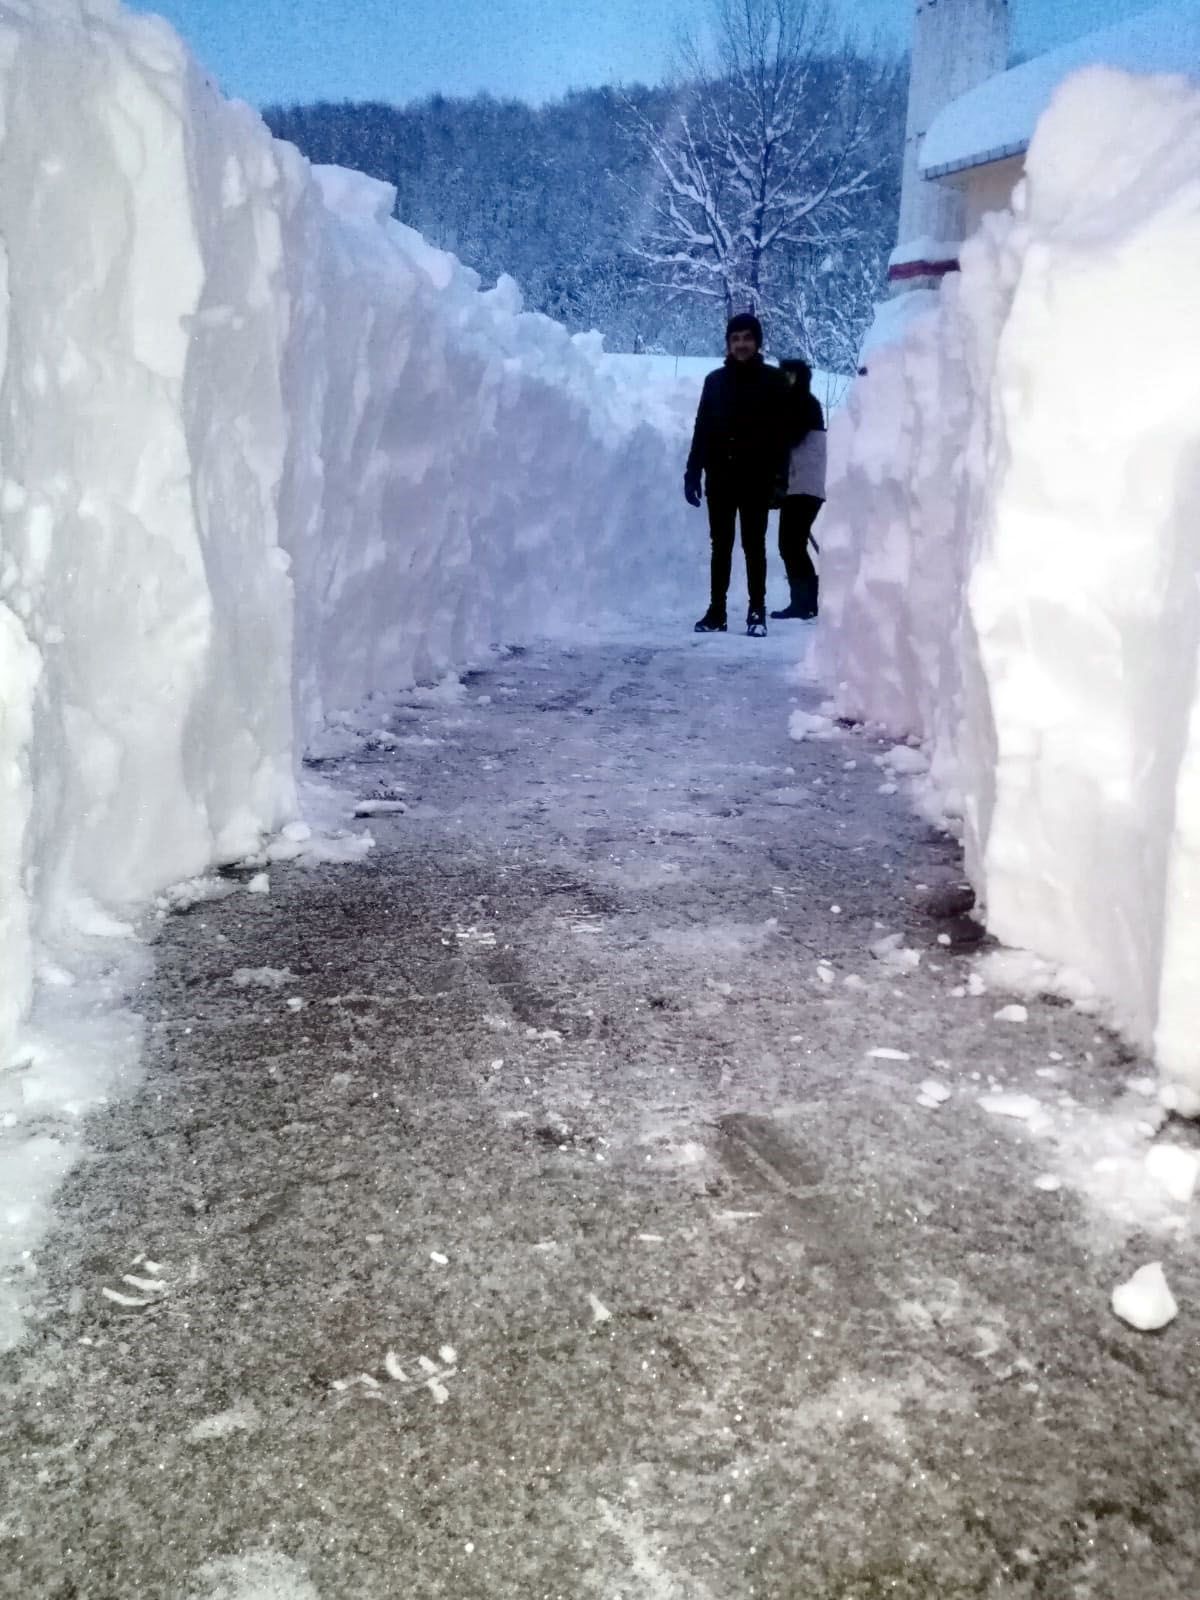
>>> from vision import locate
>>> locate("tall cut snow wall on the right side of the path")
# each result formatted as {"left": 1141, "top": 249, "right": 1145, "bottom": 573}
{"left": 821, "top": 69, "right": 1200, "bottom": 1114}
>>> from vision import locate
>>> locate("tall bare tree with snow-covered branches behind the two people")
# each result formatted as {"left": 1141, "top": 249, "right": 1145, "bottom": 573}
{"left": 630, "top": 0, "right": 899, "bottom": 363}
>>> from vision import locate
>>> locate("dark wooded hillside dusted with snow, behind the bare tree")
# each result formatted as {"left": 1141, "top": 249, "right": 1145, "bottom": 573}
{"left": 264, "top": 74, "right": 904, "bottom": 370}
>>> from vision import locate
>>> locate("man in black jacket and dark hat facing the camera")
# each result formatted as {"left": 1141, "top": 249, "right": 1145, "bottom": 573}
{"left": 683, "top": 312, "right": 790, "bottom": 637}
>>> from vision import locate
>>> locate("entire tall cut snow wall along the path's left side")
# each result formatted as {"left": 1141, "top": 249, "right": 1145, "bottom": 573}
{"left": 0, "top": 0, "right": 704, "bottom": 1064}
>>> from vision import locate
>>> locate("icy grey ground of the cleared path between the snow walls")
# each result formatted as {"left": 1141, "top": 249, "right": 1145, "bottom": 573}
{"left": 0, "top": 626, "right": 1200, "bottom": 1600}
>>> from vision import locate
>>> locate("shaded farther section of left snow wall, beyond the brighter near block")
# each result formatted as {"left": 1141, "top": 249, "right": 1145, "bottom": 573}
{"left": 296, "top": 168, "right": 698, "bottom": 734}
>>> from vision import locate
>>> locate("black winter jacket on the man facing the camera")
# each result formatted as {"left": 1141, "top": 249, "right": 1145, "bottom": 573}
{"left": 685, "top": 357, "right": 792, "bottom": 501}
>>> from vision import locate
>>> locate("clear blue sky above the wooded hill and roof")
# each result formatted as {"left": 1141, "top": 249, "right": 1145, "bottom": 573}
{"left": 134, "top": 0, "right": 1147, "bottom": 106}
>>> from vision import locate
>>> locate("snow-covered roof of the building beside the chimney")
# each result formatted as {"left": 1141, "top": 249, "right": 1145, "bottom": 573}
{"left": 920, "top": 0, "right": 1200, "bottom": 178}
